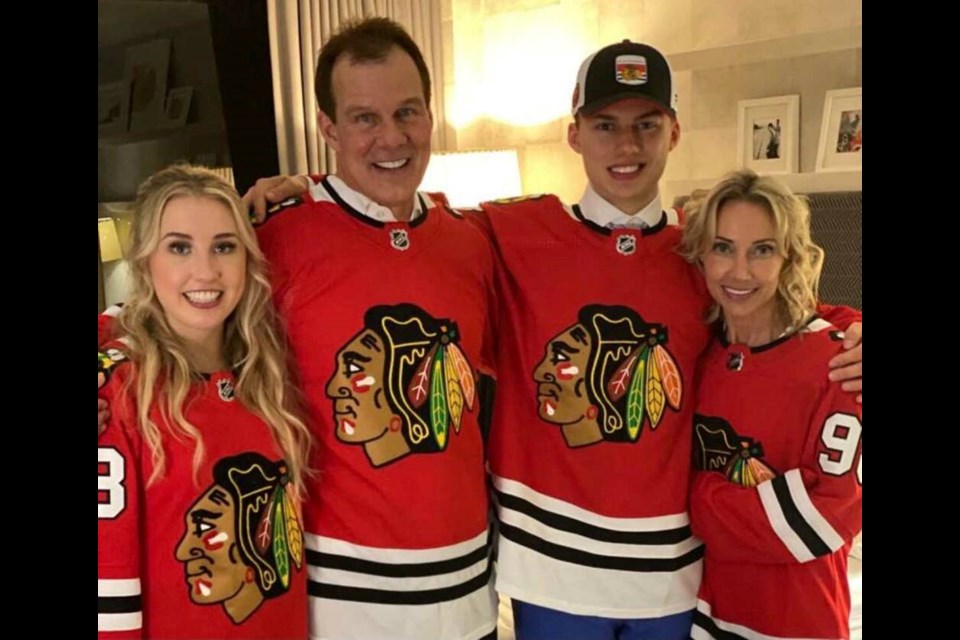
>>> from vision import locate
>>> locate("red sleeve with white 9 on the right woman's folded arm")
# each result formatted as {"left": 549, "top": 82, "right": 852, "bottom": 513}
{"left": 690, "top": 384, "right": 863, "bottom": 564}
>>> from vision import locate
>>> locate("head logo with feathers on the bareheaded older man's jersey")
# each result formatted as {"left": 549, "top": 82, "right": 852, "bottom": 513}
{"left": 327, "top": 304, "right": 476, "bottom": 467}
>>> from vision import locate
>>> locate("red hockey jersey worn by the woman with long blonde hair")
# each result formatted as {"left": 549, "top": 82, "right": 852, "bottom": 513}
{"left": 97, "top": 349, "right": 307, "bottom": 639}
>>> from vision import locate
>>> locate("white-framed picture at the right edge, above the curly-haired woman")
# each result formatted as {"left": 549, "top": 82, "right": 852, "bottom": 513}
{"left": 817, "top": 87, "right": 863, "bottom": 171}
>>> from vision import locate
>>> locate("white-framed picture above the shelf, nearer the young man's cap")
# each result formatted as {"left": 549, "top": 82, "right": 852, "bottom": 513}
{"left": 737, "top": 95, "right": 800, "bottom": 174}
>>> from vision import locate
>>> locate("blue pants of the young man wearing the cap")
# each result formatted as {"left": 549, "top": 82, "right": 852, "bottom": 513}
{"left": 513, "top": 600, "right": 693, "bottom": 640}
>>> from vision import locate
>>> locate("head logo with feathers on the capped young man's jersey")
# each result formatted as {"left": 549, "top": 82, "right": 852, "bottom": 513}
{"left": 533, "top": 305, "right": 683, "bottom": 447}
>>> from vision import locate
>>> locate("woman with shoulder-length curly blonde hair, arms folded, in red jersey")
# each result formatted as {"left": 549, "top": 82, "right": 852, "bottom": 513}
{"left": 683, "top": 171, "right": 863, "bottom": 640}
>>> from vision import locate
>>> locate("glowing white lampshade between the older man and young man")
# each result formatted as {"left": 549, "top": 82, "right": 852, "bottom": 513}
{"left": 420, "top": 149, "right": 523, "bottom": 207}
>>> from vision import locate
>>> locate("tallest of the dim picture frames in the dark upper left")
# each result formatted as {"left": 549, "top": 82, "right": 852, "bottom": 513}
{"left": 123, "top": 38, "right": 170, "bottom": 132}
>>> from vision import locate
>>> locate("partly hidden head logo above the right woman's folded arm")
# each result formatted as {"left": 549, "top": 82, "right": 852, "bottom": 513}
{"left": 693, "top": 415, "right": 777, "bottom": 488}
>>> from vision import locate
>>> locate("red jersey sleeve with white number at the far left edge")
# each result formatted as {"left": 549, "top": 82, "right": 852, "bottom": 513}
{"left": 97, "top": 375, "right": 143, "bottom": 640}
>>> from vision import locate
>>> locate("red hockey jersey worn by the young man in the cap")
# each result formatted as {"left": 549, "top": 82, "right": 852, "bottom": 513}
{"left": 481, "top": 196, "right": 709, "bottom": 618}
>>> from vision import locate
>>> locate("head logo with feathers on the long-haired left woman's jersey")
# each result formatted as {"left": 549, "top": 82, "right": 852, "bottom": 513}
{"left": 176, "top": 453, "right": 303, "bottom": 624}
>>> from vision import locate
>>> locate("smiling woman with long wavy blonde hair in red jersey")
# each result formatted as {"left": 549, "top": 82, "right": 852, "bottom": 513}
{"left": 97, "top": 166, "right": 310, "bottom": 638}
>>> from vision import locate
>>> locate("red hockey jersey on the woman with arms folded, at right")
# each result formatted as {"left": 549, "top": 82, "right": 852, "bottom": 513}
{"left": 690, "top": 320, "right": 863, "bottom": 640}
